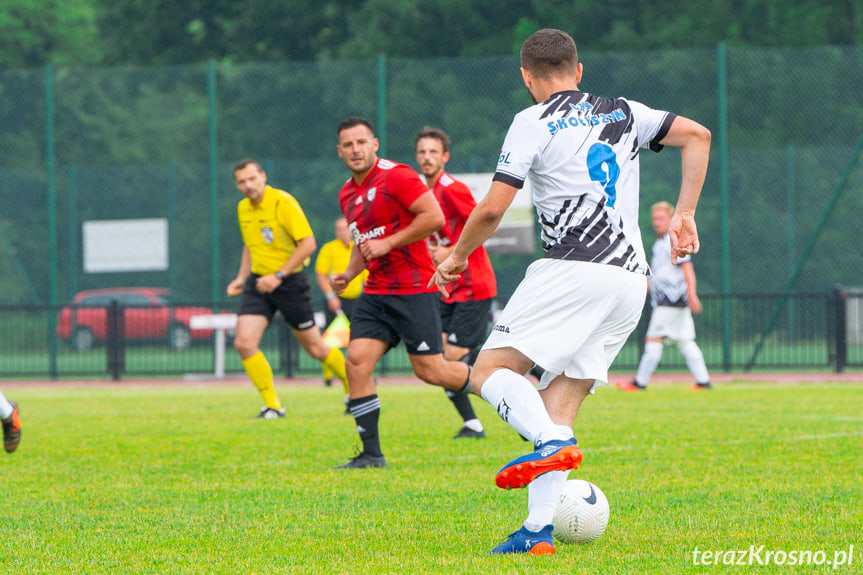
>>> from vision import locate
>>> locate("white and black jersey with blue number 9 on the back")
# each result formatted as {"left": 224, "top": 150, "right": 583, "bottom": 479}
{"left": 494, "top": 90, "right": 675, "bottom": 275}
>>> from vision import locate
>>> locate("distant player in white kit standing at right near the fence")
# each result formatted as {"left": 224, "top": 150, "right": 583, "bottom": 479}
{"left": 615, "top": 202, "right": 710, "bottom": 391}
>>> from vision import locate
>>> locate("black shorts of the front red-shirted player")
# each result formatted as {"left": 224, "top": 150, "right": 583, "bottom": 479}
{"left": 351, "top": 292, "right": 443, "bottom": 355}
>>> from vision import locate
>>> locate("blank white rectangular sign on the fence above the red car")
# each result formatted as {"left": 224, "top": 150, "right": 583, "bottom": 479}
{"left": 82, "top": 218, "right": 168, "bottom": 273}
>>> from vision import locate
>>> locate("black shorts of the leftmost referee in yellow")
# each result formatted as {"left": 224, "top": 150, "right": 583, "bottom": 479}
{"left": 238, "top": 271, "right": 315, "bottom": 331}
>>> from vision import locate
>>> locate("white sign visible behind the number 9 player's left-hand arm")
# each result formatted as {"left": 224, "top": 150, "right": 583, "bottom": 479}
{"left": 451, "top": 173, "right": 536, "bottom": 254}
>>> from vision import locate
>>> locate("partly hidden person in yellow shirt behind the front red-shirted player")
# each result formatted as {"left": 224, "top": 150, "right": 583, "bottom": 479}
{"left": 315, "top": 218, "right": 369, "bottom": 394}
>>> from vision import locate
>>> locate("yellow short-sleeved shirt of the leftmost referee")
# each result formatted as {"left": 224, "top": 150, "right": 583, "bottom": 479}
{"left": 237, "top": 186, "right": 312, "bottom": 276}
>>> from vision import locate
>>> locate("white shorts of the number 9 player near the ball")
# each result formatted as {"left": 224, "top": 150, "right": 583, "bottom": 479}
{"left": 483, "top": 259, "right": 647, "bottom": 389}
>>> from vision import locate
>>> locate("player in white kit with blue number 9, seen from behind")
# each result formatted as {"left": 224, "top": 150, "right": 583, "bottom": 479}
{"left": 430, "top": 29, "right": 710, "bottom": 554}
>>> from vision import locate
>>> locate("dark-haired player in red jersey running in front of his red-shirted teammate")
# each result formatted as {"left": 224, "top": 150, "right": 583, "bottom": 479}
{"left": 330, "top": 117, "right": 470, "bottom": 469}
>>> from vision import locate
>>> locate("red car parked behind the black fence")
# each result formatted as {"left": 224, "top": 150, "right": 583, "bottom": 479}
{"left": 57, "top": 287, "right": 219, "bottom": 351}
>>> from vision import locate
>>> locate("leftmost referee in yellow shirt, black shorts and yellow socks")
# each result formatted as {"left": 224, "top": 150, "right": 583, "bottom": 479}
{"left": 227, "top": 159, "right": 347, "bottom": 419}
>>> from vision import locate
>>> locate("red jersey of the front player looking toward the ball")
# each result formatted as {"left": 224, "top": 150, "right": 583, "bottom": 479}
{"left": 339, "top": 158, "right": 436, "bottom": 295}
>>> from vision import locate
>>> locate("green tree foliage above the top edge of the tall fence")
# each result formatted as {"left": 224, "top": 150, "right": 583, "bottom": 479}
{"left": 0, "top": 0, "right": 863, "bottom": 69}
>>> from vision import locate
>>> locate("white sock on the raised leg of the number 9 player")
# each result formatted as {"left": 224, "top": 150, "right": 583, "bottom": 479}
{"left": 480, "top": 369, "right": 572, "bottom": 445}
